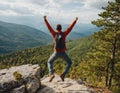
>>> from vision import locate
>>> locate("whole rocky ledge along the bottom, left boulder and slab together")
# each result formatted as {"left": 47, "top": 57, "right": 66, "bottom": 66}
{"left": 0, "top": 64, "right": 104, "bottom": 93}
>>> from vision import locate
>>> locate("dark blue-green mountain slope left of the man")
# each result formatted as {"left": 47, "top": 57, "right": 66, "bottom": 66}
{"left": 0, "top": 21, "right": 51, "bottom": 54}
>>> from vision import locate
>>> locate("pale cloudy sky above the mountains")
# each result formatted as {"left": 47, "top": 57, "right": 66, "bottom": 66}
{"left": 0, "top": 0, "right": 114, "bottom": 27}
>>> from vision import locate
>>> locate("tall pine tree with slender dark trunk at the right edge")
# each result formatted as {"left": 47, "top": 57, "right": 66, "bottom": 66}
{"left": 92, "top": 0, "right": 120, "bottom": 88}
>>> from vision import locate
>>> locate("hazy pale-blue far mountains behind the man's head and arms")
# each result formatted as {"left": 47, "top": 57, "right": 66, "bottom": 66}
{"left": 40, "top": 23, "right": 100, "bottom": 40}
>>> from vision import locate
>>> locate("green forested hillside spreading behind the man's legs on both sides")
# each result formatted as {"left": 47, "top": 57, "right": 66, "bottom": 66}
{"left": 0, "top": 33, "right": 120, "bottom": 93}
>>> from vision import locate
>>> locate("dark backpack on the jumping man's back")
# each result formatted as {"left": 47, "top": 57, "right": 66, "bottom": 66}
{"left": 55, "top": 33, "right": 65, "bottom": 50}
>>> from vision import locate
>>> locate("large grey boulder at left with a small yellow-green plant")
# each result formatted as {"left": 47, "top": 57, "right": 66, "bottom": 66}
{"left": 0, "top": 64, "right": 41, "bottom": 93}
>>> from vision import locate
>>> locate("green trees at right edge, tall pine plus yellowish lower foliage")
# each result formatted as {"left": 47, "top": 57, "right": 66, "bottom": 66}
{"left": 87, "top": 0, "right": 120, "bottom": 90}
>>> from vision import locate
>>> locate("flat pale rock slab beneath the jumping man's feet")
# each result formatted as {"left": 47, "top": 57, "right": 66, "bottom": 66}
{"left": 37, "top": 75, "right": 94, "bottom": 93}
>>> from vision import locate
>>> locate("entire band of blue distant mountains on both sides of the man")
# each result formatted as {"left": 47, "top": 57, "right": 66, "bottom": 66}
{"left": 0, "top": 21, "right": 99, "bottom": 54}
